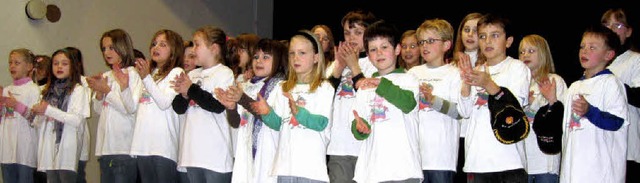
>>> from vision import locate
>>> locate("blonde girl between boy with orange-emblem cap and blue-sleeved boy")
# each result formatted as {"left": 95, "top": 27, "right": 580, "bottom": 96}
{"left": 519, "top": 34, "right": 567, "bottom": 183}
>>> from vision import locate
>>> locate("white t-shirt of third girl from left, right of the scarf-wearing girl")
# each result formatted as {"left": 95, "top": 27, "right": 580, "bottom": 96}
{"left": 93, "top": 67, "right": 142, "bottom": 156}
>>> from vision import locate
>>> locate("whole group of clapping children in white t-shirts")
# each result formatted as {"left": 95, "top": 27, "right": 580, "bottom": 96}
{"left": 0, "top": 6, "right": 640, "bottom": 183}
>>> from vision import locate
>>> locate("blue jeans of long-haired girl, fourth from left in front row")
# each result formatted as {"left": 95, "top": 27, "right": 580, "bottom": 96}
{"left": 137, "top": 156, "right": 178, "bottom": 183}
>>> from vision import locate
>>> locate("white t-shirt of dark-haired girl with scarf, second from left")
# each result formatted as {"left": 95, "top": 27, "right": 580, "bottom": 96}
{"left": 35, "top": 85, "right": 91, "bottom": 172}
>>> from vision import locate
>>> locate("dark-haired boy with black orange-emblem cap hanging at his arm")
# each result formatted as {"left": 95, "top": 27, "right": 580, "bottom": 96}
{"left": 458, "top": 14, "right": 531, "bottom": 182}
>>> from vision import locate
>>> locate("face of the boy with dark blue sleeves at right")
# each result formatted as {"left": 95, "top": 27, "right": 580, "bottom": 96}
{"left": 580, "top": 34, "right": 614, "bottom": 74}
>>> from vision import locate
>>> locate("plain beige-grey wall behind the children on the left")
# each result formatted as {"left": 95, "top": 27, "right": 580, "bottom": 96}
{"left": 0, "top": 0, "right": 273, "bottom": 183}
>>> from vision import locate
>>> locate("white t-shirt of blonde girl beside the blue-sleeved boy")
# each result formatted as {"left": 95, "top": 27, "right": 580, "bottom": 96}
{"left": 524, "top": 73, "right": 567, "bottom": 175}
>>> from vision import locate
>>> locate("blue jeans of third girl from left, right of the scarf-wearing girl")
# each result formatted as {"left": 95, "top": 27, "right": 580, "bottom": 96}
{"left": 98, "top": 155, "right": 138, "bottom": 183}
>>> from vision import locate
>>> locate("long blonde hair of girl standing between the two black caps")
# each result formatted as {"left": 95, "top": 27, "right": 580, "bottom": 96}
{"left": 520, "top": 34, "right": 556, "bottom": 81}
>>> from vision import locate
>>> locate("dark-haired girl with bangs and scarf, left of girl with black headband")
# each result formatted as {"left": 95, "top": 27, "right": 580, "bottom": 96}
{"left": 218, "top": 39, "right": 288, "bottom": 183}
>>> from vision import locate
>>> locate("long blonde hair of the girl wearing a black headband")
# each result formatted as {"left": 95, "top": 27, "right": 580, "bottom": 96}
{"left": 282, "top": 30, "right": 325, "bottom": 92}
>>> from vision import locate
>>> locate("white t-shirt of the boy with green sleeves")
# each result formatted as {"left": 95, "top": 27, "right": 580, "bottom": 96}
{"left": 349, "top": 73, "right": 423, "bottom": 183}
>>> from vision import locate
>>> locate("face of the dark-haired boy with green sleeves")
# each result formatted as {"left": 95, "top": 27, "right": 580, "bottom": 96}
{"left": 367, "top": 37, "right": 400, "bottom": 75}
